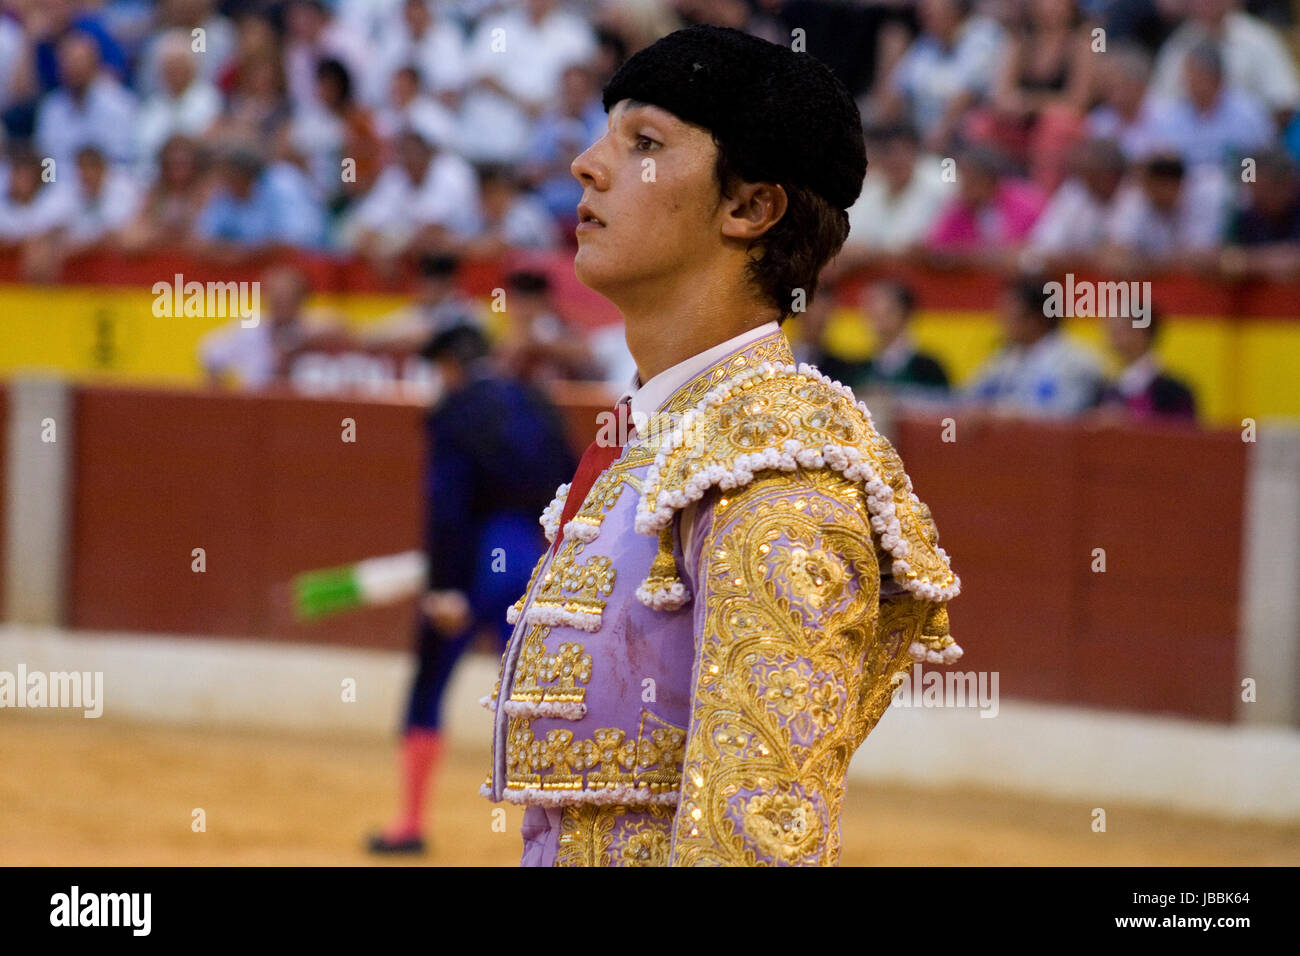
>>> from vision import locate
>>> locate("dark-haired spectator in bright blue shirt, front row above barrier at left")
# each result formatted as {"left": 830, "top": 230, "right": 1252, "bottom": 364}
{"left": 195, "top": 146, "right": 325, "bottom": 256}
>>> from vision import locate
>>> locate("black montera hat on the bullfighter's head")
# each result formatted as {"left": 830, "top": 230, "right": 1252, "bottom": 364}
{"left": 602, "top": 23, "right": 867, "bottom": 209}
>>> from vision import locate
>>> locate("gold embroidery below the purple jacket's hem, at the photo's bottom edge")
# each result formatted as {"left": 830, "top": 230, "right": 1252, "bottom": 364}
{"left": 555, "top": 804, "right": 672, "bottom": 866}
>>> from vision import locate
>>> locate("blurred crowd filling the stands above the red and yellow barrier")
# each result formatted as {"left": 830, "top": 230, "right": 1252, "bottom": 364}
{"left": 0, "top": 0, "right": 1279, "bottom": 421}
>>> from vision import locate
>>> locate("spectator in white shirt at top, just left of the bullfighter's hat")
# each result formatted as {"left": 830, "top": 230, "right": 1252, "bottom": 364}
{"left": 460, "top": 0, "right": 595, "bottom": 163}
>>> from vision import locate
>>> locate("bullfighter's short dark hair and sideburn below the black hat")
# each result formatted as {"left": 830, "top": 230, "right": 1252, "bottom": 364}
{"left": 714, "top": 137, "right": 849, "bottom": 323}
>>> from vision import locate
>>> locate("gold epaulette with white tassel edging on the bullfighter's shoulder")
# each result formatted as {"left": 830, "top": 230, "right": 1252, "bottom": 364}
{"left": 636, "top": 363, "right": 961, "bottom": 613}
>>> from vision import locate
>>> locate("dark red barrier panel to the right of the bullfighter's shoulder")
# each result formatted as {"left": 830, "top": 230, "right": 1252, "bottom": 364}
{"left": 898, "top": 416, "right": 1247, "bottom": 721}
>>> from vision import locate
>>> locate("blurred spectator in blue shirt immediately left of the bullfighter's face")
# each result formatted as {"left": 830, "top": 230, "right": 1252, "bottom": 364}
{"left": 520, "top": 64, "right": 603, "bottom": 230}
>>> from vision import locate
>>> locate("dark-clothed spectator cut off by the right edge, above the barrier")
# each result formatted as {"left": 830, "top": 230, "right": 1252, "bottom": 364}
{"left": 1219, "top": 147, "right": 1300, "bottom": 281}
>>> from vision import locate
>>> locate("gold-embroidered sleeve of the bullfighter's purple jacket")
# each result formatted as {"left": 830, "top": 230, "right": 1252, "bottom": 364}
{"left": 673, "top": 470, "right": 909, "bottom": 865}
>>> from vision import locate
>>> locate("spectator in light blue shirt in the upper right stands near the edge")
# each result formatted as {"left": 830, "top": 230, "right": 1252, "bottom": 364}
{"left": 1151, "top": 42, "right": 1277, "bottom": 166}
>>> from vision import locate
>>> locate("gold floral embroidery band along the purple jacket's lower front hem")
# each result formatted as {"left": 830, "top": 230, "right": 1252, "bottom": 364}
{"left": 506, "top": 710, "right": 686, "bottom": 793}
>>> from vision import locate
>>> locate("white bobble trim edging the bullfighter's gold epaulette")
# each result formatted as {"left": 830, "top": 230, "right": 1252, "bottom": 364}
{"left": 634, "top": 362, "right": 962, "bottom": 602}
